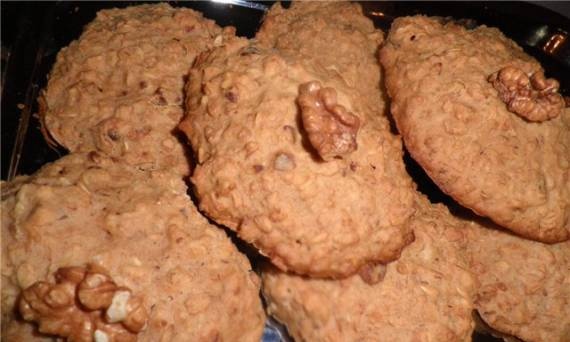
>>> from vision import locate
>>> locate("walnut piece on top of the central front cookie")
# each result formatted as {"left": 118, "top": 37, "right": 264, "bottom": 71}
{"left": 297, "top": 81, "right": 360, "bottom": 161}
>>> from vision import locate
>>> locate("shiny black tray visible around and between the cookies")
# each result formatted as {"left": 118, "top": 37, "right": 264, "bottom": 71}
{"left": 0, "top": 0, "right": 570, "bottom": 342}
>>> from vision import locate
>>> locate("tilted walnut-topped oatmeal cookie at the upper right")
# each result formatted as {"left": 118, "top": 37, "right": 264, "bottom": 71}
{"left": 380, "top": 16, "right": 570, "bottom": 243}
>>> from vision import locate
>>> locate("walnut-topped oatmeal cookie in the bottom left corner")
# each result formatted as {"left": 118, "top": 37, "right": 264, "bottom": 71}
{"left": 2, "top": 152, "right": 264, "bottom": 342}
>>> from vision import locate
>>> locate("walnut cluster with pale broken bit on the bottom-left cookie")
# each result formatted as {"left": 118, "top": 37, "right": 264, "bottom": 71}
{"left": 18, "top": 265, "right": 147, "bottom": 342}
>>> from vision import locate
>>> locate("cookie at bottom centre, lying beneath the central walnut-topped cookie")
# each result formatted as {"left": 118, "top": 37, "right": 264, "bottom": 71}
{"left": 262, "top": 199, "right": 475, "bottom": 341}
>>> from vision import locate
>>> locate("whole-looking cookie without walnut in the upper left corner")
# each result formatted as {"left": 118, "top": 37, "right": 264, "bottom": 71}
{"left": 40, "top": 4, "right": 233, "bottom": 174}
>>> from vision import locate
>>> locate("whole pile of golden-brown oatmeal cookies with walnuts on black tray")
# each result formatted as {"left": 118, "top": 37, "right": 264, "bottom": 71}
{"left": 2, "top": 2, "right": 570, "bottom": 342}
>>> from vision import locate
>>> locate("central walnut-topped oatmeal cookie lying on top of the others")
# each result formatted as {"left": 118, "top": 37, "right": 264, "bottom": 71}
{"left": 181, "top": 39, "right": 414, "bottom": 277}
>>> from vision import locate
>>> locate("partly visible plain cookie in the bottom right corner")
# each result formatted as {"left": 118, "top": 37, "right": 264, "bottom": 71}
{"left": 467, "top": 219, "right": 570, "bottom": 342}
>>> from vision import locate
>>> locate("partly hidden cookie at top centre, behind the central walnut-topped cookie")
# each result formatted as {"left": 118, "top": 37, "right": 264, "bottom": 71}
{"left": 255, "top": 1, "right": 385, "bottom": 112}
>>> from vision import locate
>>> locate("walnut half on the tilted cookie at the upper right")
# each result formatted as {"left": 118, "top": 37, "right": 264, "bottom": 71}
{"left": 488, "top": 67, "right": 565, "bottom": 122}
